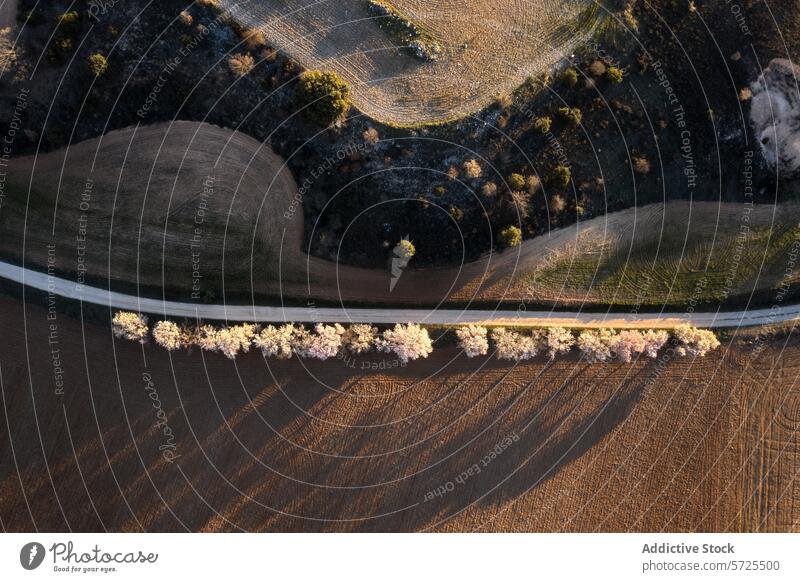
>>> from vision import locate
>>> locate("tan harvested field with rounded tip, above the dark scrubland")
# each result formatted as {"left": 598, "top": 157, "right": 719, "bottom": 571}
{"left": 221, "top": 0, "right": 602, "bottom": 124}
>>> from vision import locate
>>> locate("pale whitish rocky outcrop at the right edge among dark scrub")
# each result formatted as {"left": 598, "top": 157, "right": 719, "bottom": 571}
{"left": 750, "top": 59, "right": 800, "bottom": 179}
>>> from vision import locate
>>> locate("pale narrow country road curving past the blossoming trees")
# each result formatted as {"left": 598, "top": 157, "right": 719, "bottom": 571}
{"left": 0, "top": 261, "right": 800, "bottom": 329}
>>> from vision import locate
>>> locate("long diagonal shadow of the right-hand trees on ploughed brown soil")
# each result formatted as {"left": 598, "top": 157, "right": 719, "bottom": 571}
{"left": 384, "top": 364, "right": 652, "bottom": 530}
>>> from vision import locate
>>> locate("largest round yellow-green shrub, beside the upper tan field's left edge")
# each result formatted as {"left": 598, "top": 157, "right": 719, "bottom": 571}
{"left": 295, "top": 71, "right": 350, "bottom": 126}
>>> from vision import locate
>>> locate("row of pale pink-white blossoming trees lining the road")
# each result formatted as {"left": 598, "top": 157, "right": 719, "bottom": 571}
{"left": 112, "top": 312, "right": 719, "bottom": 363}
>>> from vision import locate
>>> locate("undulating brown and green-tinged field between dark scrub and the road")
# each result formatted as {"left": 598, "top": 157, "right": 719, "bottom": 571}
{"left": 0, "top": 122, "right": 800, "bottom": 305}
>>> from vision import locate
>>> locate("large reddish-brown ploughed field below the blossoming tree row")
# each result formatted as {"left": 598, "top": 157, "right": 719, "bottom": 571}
{"left": 0, "top": 297, "right": 800, "bottom": 532}
